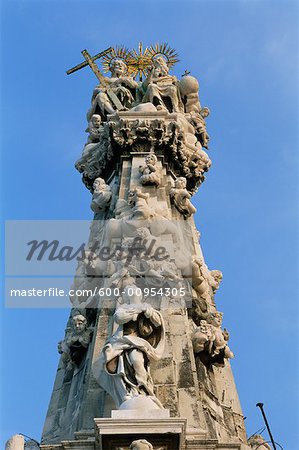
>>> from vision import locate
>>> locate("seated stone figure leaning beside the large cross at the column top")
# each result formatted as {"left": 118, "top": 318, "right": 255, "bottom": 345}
{"left": 87, "top": 59, "right": 138, "bottom": 120}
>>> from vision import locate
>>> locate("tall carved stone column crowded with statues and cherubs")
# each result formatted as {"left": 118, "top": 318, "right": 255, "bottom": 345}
{"left": 7, "top": 44, "right": 255, "bottom": 450}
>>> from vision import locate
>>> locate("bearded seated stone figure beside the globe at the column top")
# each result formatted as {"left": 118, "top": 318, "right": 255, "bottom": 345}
{"left": 141, "top": 56, "right": 183, "bottom": 112}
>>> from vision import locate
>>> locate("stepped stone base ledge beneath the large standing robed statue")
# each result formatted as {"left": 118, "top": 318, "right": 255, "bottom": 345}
{"left": 40, "top": 418, "right": 250, "bottom": 450}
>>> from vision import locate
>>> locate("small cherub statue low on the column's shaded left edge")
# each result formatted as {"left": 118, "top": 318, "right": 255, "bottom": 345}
{"left": 58, "top": 310, "right": 93, "bottom": 370}
